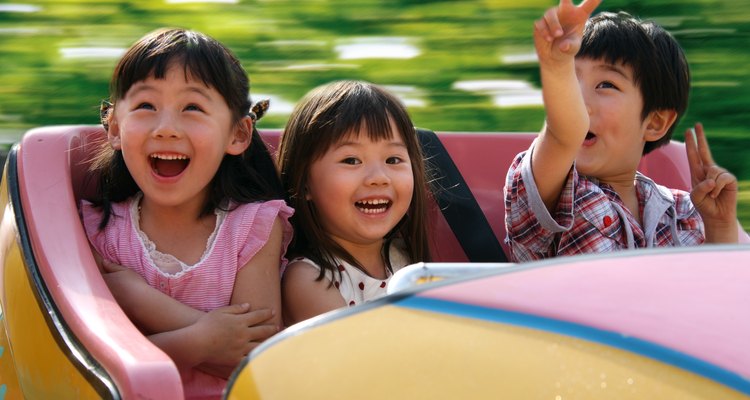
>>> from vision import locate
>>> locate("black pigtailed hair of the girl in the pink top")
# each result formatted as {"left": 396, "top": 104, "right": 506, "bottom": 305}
{"left": 91, "top": 28, "right": 284, "bottom": 229}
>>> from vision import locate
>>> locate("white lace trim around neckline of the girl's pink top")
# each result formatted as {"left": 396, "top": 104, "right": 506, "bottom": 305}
{"left": 130, "top": 193, "right": 227, "bottom": 278}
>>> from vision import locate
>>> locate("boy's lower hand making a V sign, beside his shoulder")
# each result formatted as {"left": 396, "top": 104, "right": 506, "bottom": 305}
{"left": 685, "top": 123, "right": 738, "bottom": 243}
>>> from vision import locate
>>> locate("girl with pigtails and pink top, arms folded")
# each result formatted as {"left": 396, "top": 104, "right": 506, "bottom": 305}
{"left": 81, "top": 29, "right": 292, "bottom": 398}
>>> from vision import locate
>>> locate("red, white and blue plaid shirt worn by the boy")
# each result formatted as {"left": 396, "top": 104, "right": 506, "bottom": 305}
{"left": 504, "top": 145, "right": 705, "bottom": 262}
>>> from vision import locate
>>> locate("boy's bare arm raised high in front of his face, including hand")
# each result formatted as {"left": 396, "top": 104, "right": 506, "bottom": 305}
{"left": 531, "top": 0, "right": 601, "bottom": 210}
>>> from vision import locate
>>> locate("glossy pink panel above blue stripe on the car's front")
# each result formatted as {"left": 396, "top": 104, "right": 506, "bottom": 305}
{"left": 420, "top": 245, "right": 750, "bottom": 377}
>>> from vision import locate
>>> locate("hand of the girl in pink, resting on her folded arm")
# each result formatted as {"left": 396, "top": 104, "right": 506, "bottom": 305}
{"left": 194, "top": 303, "right": 279, "bottom": 367}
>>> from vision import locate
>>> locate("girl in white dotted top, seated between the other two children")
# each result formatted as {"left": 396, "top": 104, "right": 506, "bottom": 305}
{"left": 279, "top": 81, "right": 429, "bottom": 324}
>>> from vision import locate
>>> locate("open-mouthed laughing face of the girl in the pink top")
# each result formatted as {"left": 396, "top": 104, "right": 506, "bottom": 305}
{"left": 108, "top": 64, "right": 248, "bottom": 210}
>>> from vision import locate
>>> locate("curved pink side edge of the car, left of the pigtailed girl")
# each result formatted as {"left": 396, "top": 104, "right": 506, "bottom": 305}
{"left": 17, "top": 126, "right": 183, "bottom": 399}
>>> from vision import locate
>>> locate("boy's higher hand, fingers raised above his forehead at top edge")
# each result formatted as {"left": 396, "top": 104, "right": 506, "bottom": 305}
{"left": 534, "top": 0, "right": 601, "bottom": 63}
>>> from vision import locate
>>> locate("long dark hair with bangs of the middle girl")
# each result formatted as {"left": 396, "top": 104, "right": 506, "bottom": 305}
{"left": 278, "top": 81, "right": 430, "bottom": 280}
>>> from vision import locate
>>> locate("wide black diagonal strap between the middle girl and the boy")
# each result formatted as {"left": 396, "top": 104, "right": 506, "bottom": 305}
{"left": 416, "top": 128, "right": 508, "bottom": 262}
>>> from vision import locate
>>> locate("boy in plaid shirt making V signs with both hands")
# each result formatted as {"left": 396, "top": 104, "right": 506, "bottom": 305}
{"left": 505, "top": 0, "right": 738, "bottom": 261}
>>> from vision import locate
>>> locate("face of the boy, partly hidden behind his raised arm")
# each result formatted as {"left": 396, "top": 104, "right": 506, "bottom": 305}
{"left": 575, "top": 58, "right": 653, "bottom": 181}
